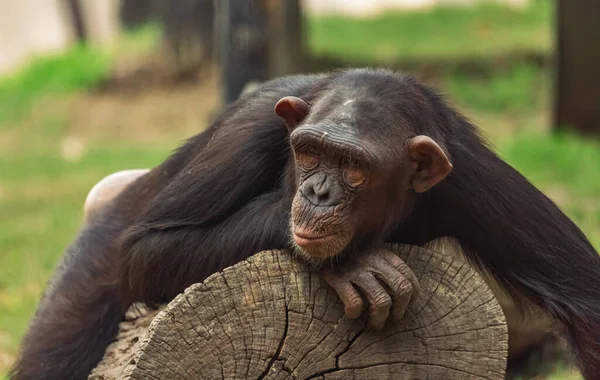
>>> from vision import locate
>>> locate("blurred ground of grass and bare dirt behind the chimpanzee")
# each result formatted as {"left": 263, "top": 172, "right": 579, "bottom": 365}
{"left": 0, "top": 0, "right": 600, "bottom": 379}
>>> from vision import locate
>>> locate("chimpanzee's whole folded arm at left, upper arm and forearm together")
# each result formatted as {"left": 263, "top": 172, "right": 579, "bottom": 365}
{"left": 116, "top": 104, "right": 290, "bottom": 302}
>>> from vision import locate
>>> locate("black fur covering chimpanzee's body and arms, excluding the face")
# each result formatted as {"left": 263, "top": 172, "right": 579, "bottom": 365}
{"left": 13, "top": 69, "right": 600, "bottom": 379}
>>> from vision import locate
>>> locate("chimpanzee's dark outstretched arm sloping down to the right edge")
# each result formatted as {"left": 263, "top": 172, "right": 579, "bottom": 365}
{"left": 423, "top": 131, "right": 600, "bottom": 379}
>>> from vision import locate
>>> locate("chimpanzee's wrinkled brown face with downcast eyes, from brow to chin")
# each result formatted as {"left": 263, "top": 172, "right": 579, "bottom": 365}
{"left": 290, "top": 126, "right": 370, "bottom": 261}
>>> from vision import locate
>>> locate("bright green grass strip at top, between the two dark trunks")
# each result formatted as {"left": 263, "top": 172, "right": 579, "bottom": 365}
{"left": 307, "top": 0, "right": 554, "bottom": 62}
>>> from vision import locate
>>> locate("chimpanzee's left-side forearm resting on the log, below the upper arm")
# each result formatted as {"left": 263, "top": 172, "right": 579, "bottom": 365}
{"left": 122, "top": 191, "right": 289, "bottom": 302}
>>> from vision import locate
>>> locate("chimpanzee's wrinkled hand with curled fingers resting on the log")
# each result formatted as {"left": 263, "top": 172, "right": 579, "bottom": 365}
{"left": 324, "top": 249, "right": 419, "bottom": 329}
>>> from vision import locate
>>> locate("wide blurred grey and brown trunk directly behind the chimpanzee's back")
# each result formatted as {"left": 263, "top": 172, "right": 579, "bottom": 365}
{"left": 215, "top": 0, "right": 305, "bottom": 104}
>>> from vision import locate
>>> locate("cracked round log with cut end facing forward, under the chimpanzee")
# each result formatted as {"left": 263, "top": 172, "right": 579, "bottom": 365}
{"left": 90, "top": 245, "right": 508, "bottom": 380}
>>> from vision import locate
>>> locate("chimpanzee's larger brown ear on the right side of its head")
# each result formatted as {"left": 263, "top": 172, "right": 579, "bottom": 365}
{"left": 407, "top": 136, "right": 452, "bottom": 193}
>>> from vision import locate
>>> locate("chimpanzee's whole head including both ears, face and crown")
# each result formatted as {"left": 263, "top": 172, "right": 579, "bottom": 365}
{"left": 275, "top": 71, "right": 452, "bottom": 260}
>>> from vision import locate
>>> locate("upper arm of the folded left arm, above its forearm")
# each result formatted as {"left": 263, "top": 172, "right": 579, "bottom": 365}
{"left": 142, "top": 120, "right": 288, "bottom": 228}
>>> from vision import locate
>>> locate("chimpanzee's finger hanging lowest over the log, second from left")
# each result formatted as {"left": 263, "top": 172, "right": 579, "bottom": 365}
{"left": 351, "top": 272, "right": 392, "bottom": 330}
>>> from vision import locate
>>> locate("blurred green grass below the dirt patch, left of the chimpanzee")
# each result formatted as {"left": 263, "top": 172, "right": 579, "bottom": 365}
{"left": 0, "top": 145, "right": 171, "bottom": 352}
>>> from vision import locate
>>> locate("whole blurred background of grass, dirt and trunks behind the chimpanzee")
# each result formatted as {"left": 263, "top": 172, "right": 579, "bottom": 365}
{"left": 0, "top": 0, "right": 600, "bottom": 379}
